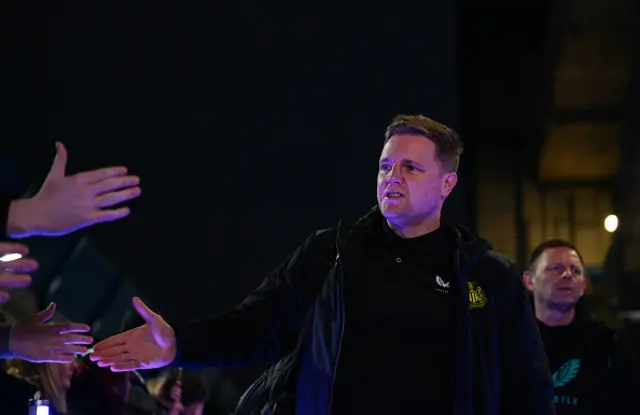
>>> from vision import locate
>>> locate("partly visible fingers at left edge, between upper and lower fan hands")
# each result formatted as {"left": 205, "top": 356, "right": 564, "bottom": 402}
{"left": 0, "top": 242, "right": 38, "bottom": 304}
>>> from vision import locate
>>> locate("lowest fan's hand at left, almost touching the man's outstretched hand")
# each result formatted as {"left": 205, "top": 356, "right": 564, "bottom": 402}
{"left": 9, "top": 303, "right": 93, "bottom": 363}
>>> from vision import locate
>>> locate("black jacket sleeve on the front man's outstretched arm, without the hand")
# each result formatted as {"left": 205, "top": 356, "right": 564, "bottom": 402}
{"left": 175, "top": 232, "right": 335, "bottom": 367}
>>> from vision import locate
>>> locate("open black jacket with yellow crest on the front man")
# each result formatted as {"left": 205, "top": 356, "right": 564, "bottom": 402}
{"left": 175, "top": 208, "right": 555, "bottom": 415}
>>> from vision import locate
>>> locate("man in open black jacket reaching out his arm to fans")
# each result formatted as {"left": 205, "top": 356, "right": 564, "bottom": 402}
{"left": 91, "top": 115, "right": 554, "bottom": 415}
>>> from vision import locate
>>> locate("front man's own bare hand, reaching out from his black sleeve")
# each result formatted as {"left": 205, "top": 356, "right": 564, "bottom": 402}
{"left": 89, "top": 298, "right": 176, "bottom": 372}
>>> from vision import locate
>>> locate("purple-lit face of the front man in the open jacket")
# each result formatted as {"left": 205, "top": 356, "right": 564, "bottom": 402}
{"left": 378, "top": 134, "right": 457, "bottom": 226}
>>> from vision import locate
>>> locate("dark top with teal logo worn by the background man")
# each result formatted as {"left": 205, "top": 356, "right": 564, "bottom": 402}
{"left": 539, "top": 306, "right": 640, "bottom": 415}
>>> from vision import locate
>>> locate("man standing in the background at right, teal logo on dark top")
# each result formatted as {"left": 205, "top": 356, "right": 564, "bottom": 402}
{"left": 523, "top": 239, "right": 640, "bottom": 415}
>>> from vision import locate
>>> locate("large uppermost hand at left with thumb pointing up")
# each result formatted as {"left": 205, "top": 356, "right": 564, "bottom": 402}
{"left": 7, "top": 143, "right": 140, "bottom": 238}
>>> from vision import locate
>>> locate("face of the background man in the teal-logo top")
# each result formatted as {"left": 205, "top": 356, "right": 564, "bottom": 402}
{"left": 523, "top": 247, "right": 587, "bottom": 308}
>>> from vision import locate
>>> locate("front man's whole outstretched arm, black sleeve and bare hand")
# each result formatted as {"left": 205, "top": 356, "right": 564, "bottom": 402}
{"left": 91, "top": 231, "right": 335, "bottom": 371}
